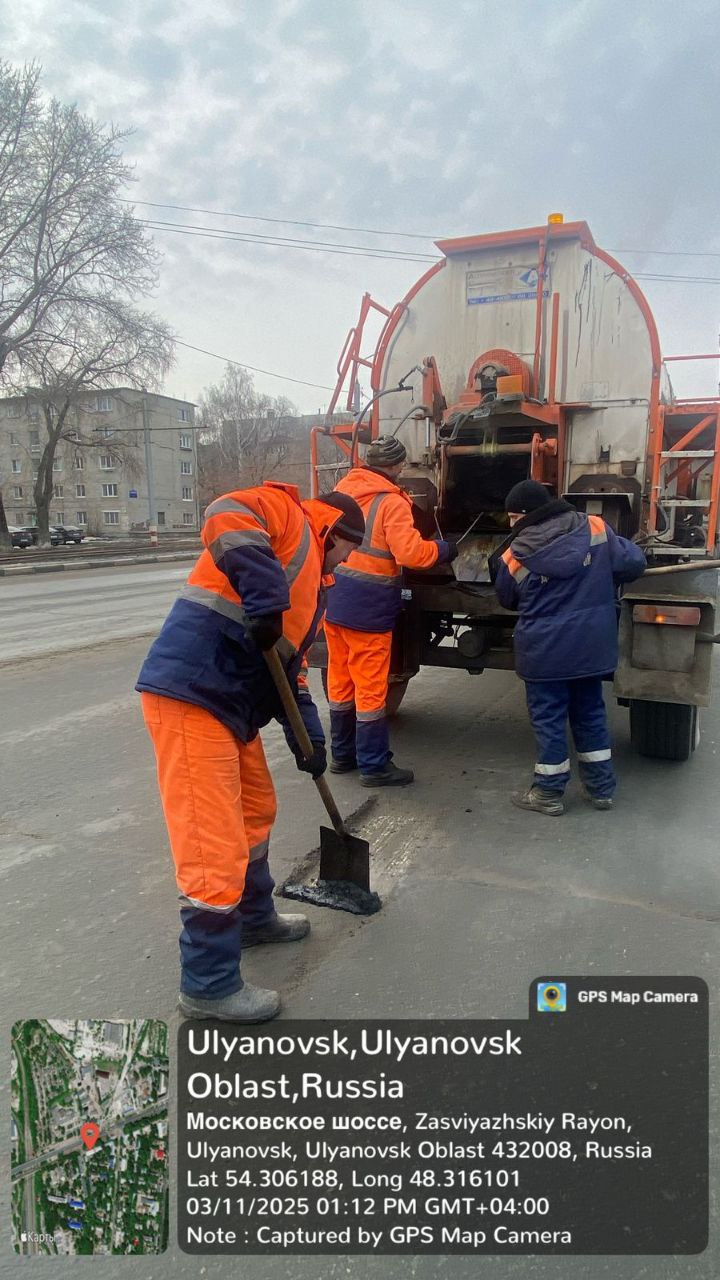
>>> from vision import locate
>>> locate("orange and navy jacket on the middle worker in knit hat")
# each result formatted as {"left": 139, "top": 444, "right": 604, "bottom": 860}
{"left": 327, "top": 467, "right": 448, "bottom": 631}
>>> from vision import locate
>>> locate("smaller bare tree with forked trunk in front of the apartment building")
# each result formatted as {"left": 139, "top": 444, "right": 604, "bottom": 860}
{"left": 18, "top": 302, "right": 173, "bottom": 544}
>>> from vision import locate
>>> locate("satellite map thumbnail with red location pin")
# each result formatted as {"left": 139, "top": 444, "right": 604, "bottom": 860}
{"left": 12, "top": 1019, "right": 168, "bottom": 1254}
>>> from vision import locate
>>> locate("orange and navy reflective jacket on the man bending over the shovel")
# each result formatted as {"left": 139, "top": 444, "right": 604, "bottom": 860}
{"left": 136, "top": 481, "right": 342, "bottom": 741}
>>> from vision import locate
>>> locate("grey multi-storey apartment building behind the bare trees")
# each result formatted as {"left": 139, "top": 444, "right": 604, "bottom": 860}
{"left": 0, "top": 387, "right": 199, "bottom": 538}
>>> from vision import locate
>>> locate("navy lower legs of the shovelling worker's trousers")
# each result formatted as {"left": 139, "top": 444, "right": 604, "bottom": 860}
{"left": 179, "top": 855, "right": 275, "bottom": 1000}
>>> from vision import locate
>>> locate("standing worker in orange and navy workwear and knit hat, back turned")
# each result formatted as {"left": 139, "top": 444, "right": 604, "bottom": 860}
{"left": 324, "top": 435, "right": 457, "bottom": 787}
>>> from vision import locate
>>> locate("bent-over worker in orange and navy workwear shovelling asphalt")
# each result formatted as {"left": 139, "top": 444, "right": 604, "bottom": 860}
{"left": 136, "top": 483, "right": 364, "bottom": 1023}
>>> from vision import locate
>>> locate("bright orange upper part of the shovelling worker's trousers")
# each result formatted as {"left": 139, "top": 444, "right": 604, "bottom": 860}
{"left": 141, "top": 694, "right": 277, "bottom": 924}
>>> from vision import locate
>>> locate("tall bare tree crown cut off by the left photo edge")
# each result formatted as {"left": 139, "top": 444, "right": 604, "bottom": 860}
{"left": 0, "top": 60, "right": 159, "bottom": 545}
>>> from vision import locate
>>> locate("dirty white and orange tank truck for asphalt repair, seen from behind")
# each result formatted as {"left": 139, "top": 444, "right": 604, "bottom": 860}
{"left": 311, "top": 214, "right": 720, "bottom": 760}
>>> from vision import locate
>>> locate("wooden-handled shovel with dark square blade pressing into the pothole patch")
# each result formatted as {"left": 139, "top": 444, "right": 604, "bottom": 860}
{"left": 260, "top": 648, "right": 380, "bottom": 915}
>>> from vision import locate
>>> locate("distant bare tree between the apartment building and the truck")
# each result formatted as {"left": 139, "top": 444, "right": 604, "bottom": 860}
{"left": 197, "top": 365, "right": 297, "bottom": 497}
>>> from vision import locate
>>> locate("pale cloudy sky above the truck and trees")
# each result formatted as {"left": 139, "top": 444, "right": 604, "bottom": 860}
{"left": 0, "top": 0, "right": 720, "bottom": 412}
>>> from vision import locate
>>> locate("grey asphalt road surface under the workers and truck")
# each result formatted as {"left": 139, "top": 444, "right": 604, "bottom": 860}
{"left": 0, "top": 567, "right": 720, "bottom": 1280}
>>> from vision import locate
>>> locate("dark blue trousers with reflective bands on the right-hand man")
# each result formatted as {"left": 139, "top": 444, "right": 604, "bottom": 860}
{"left": 525, "top": 676, "right": 616, "bottom": 799}
